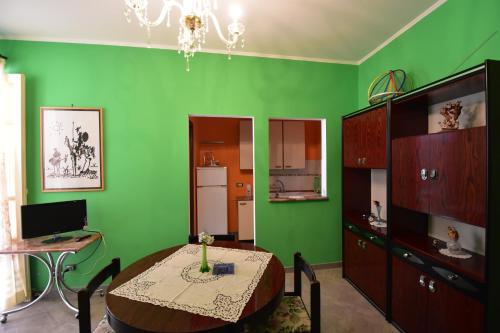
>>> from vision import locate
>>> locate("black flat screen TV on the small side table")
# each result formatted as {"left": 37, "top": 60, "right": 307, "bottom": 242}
{"left": 21, "top": 200, "right": 87, "bottom": 243}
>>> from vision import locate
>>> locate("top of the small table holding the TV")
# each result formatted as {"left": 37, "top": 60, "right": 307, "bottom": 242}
{"left": 0, "top": 233, "right": 101, "bottom": 254}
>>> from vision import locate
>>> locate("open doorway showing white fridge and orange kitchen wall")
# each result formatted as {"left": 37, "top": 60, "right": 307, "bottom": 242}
{"left": 189, "top": 116, "right": 255, "bottom": 243}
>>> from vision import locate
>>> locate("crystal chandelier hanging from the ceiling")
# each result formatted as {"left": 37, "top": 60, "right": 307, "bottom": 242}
{"left": 125, "top": 0, "right": 245, "bottom": 71}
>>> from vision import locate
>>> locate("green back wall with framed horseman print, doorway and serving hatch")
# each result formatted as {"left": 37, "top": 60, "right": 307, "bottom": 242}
{"left": 0, "top": 41, "right": 357, "bottom": 289}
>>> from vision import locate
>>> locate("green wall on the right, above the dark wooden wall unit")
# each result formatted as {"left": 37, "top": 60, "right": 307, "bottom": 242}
{"left": 358, "top": 0, "right": 500, "bottom": 108}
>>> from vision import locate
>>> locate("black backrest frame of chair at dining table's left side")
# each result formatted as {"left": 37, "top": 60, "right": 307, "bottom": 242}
{"left": 78, "top": 258, "right": 120, "bottom": 333}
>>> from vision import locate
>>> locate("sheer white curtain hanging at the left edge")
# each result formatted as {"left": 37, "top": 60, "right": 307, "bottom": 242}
{"left": 0, "top": 58, "right": 30, "bottom": 311}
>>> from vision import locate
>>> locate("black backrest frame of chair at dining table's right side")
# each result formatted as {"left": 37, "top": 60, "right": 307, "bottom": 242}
{"left": 292, "top": 252, "right": 321, "bottom": 333}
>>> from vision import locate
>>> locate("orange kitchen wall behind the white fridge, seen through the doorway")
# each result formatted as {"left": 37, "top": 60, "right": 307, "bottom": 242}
{"left": 189, "top": 117, "right": 253, "bottom": 232}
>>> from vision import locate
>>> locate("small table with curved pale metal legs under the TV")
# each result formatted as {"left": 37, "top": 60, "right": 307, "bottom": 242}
{"left": 0, "top": 233, "right": 101, "bottom": 324}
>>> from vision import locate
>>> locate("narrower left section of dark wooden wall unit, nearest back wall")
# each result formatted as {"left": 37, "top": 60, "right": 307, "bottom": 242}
{"left": 342, "top": 104, "right": 388, "bottom": 313}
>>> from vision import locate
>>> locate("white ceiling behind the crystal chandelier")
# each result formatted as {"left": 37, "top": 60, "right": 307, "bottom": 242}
{"left": 0, "top": 0, "right": 446, "bottom": 63}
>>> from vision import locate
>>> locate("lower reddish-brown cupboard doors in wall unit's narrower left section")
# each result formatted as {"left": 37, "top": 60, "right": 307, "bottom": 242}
{"left": 343, "top": 230, "right": 387, "bottom": 312}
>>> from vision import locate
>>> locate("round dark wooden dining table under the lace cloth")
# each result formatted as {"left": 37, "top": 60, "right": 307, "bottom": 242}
{"left": 106, "top": 241, "right": 285, "bottom": 333}
